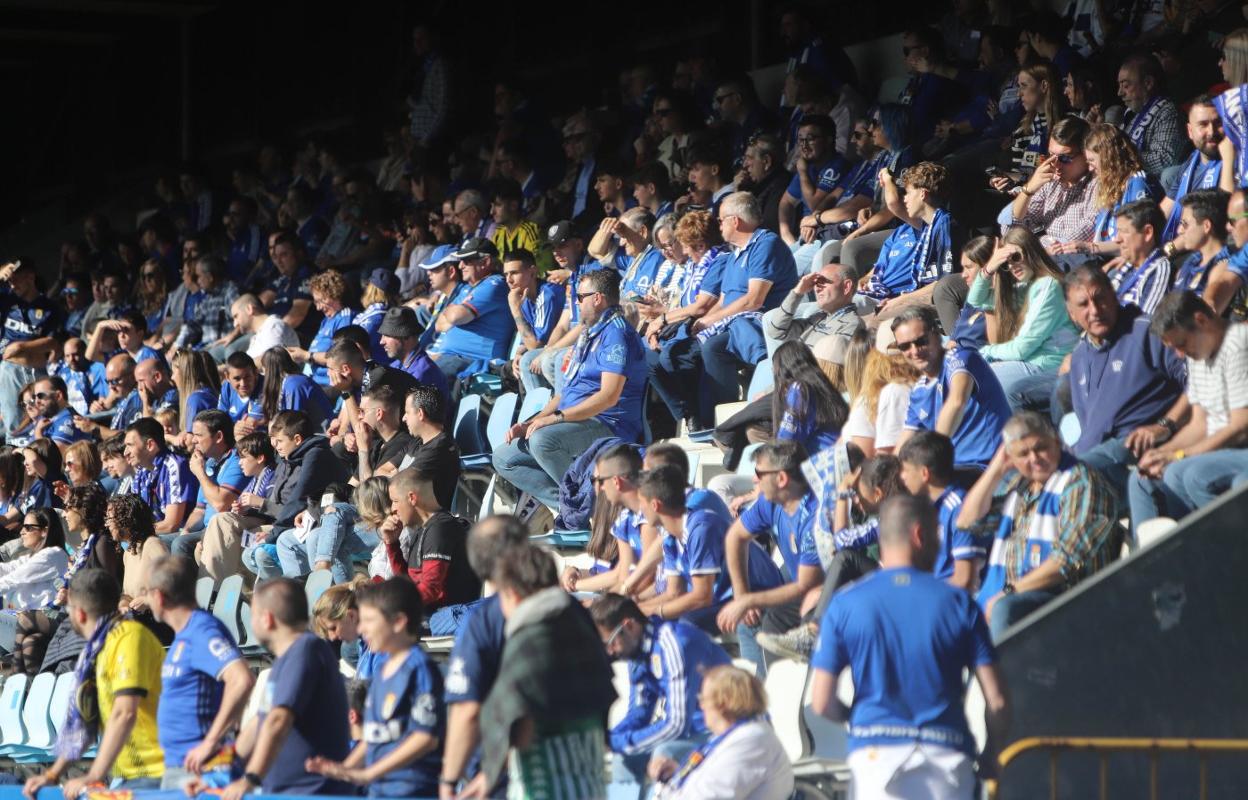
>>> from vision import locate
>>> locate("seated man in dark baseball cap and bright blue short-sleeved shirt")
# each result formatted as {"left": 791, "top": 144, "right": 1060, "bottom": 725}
{"left": 429, "top": 236, "right": 515, "bottom": 381}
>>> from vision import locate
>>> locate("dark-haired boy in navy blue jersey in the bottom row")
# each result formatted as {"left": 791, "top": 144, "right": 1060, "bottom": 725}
{"left": 306, "top": 578, "right": 446, "bottom": 798}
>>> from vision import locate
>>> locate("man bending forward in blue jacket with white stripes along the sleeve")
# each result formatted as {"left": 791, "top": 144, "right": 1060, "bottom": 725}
{"left": 589, "top": 594, "right": 731, "bottom": 798}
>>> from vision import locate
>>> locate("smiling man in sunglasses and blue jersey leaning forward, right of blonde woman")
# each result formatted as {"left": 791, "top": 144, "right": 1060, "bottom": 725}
{"left": 891, "top": 306, "right": 1010, "bottom": 469}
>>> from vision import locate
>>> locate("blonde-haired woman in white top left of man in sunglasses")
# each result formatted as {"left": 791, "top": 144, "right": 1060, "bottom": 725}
{"left": 841, "top": 331, "right": 919, "bottom": 458}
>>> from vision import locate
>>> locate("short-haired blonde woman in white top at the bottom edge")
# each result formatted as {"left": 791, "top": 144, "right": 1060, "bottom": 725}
{"left": 649, "top": 665, "right": 794, "bottom": 800}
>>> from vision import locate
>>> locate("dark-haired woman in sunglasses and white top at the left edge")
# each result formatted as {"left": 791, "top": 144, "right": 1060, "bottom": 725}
{"left": 0, "top": 508, "right": 70, "bottom": 675}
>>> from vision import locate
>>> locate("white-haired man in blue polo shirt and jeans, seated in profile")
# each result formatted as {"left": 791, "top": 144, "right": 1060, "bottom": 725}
{"left": 684, "top": 192, "right": 797, "bottom": 429}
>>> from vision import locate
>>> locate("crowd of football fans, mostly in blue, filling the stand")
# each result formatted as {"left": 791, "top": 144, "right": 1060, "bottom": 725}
{"left": 0, "top": 0, "right": 1248, "bottom": 800}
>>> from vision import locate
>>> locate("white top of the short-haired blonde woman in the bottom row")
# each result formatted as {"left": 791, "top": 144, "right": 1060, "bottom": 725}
{"left": 655, "top": 720, "right": 792, "bottom": 800}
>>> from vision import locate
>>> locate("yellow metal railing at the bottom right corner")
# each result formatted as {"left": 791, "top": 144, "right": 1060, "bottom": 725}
{"left": 987, "top": 736, "right": 1248, "bottom": 800}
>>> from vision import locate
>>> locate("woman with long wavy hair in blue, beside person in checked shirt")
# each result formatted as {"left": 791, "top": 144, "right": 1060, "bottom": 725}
{"left": 1062, "top": 122, "right": 1161, "bottom": 256}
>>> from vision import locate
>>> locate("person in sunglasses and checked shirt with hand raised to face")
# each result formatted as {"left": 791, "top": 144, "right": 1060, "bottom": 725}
{"left": 998, "top": 116, "right": 1097, "bottom": 249}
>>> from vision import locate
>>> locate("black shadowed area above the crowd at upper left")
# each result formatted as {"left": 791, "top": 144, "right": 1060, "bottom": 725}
{"left": 0, "top": 0, "right": 918, "bottom": 231}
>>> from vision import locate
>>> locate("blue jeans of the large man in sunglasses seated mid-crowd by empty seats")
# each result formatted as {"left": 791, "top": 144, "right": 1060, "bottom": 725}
{"left": 493, "top": 418, "right": 614, "bottom": 508}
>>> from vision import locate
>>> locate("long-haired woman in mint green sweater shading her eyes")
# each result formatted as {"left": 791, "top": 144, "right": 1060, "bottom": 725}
{"left": 966, "top": 226, "right": 1078, "bottom": 412}
